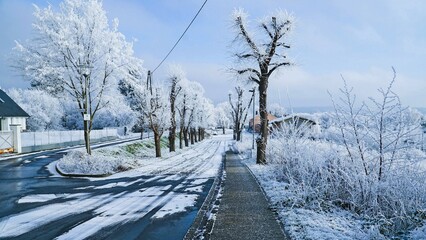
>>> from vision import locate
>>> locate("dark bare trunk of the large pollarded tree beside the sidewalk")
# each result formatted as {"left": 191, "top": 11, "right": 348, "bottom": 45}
{"left": 256, "top": 81, "right": 268, "bottom": 164}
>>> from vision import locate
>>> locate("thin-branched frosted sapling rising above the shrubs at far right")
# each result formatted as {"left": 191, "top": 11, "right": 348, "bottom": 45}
{"left": 333, "top": 70, "right": 421, "bottom": 181}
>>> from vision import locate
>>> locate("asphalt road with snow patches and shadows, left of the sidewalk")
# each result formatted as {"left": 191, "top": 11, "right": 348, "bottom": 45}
{"left": 0, "top": 138, "right": 223, "bottom": 239}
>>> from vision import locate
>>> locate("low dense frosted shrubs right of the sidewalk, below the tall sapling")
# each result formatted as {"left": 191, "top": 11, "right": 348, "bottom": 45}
{"left": 267, "top": 124, "right": 426, "bottom": 233}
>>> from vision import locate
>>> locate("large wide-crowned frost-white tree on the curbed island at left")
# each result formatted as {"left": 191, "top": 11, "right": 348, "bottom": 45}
{"left": 14, "top": 0, "right": 139, "bottom": 154}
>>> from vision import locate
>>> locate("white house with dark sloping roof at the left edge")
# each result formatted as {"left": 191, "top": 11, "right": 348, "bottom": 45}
{"left": 0, "top": 89, "right": 30, "bottom": 131}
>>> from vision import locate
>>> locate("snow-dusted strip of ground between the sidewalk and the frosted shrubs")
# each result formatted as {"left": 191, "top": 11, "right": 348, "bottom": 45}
{"left": 245, "top": 159, "right": 381, "bottom": 240}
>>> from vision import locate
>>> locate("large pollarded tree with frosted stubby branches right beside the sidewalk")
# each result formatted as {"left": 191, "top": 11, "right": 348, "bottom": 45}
{"left": 232, "top": 9, "right": 293, "bottom": 164}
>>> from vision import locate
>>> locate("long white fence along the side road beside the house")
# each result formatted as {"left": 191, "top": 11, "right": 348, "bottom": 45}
{"left": 21, "top": 128, "right": 118, "bottom": 152}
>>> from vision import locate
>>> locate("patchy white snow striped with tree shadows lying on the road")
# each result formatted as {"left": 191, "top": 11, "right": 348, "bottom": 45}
{"left": 0, "top": 136, "right": 229, "bottom": 239}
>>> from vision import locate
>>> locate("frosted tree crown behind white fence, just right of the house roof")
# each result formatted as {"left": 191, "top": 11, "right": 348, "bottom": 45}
{"left": 7, "top": 89, "right": 64, "bottom": 131}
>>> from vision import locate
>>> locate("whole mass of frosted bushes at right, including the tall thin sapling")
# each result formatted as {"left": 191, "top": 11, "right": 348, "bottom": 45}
{"left": 267, "top": 71, "right": 426, "bottom": 236}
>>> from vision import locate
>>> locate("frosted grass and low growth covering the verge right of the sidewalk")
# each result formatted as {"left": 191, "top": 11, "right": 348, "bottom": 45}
{"left": 237, "top": 130, "right": 426, "bottom": 239}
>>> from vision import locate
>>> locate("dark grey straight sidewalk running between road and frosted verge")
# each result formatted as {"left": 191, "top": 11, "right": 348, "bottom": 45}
{"left": 211, "top": 153, "right": 287, "bottom": 240}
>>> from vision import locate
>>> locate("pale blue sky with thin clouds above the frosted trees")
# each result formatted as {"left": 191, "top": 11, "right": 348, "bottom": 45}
{"left": 0, "top": 0, "right": 426, "bottom": 108}
